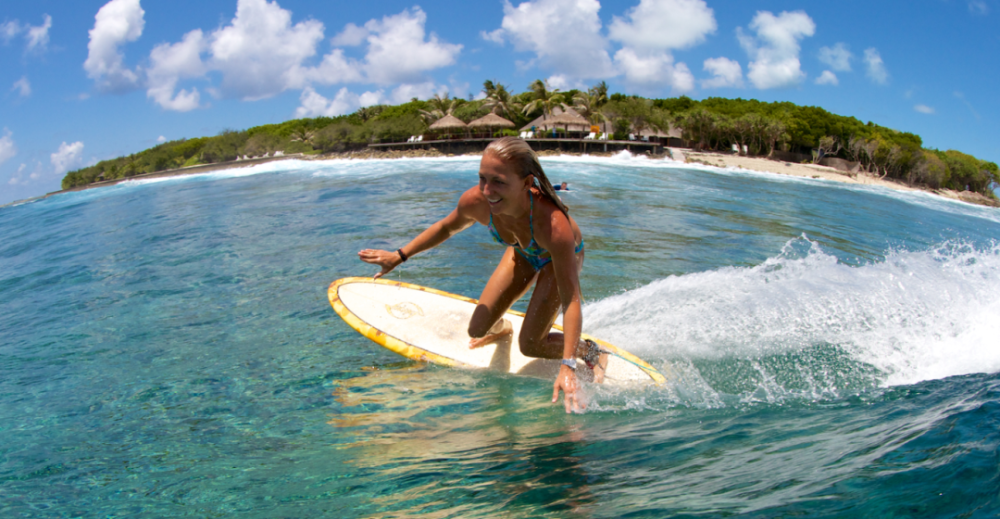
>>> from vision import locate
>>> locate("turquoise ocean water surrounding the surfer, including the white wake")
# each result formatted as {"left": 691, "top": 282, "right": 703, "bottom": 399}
{"left": 0, "top": 155, "right": 1000, "bottom": 518}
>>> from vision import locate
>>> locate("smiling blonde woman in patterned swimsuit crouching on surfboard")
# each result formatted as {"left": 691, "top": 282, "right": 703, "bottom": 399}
{"left": 358, "top": 137, "right": 608, "bottom": 412}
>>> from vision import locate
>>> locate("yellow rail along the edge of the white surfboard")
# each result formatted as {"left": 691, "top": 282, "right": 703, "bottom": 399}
{"left": 326, "top": 277, "right": 667, "bottom": 386}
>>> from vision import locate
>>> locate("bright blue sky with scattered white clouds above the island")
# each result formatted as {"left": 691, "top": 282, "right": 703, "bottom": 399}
{"left": 0, "top": 0, "right": 1000, "bottom": 204}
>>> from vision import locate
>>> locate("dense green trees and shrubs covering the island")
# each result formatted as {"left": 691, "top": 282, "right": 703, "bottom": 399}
{"left": 62, "top": 80, "right": 1000, "bottom": 197}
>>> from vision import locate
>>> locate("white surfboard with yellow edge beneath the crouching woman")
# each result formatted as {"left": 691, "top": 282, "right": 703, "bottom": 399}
{"left": 327, "top": 277, "right": 666, "bottom": 386}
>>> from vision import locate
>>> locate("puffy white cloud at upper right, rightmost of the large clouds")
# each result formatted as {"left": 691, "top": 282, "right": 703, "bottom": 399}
{"left": 736, "top": 11, "right": 816, "bottom": 89}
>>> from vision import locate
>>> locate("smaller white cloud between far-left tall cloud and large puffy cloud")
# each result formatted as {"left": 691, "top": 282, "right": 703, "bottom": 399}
{"left": 146, "top": 29, "right": 207, "bottom": 112}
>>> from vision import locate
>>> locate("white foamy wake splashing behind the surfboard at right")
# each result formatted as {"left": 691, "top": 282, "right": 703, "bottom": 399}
{"left": 584, "top": 237, "right": 1000, "bottom": 385}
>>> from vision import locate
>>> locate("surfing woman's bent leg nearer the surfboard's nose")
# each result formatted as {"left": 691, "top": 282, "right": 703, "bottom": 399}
{"left": 469, "top": 247, "right": 537, "bottom": 348}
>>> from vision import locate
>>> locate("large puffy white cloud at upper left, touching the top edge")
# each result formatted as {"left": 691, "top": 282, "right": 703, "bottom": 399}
{"left": 210, "top": 0, "right": 323, "bottom": 100}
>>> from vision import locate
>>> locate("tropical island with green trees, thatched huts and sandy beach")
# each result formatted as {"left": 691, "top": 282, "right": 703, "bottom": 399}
{"left": 62, "top": 80, "right": 1000, "bottom": 206}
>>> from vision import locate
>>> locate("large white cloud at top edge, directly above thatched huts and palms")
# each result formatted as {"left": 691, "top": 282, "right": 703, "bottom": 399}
{"left": 484, "top": 0, "right": 615, "bottom": 79}
